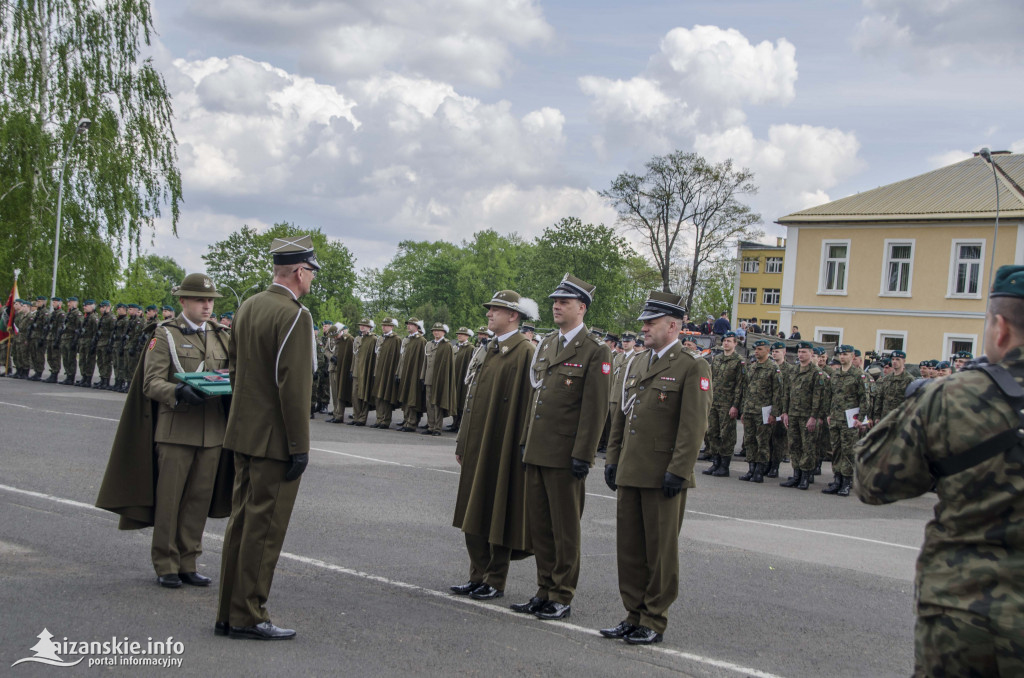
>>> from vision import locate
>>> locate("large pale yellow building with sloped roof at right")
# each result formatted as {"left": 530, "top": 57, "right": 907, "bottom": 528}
{"left": 777, "top": 153, "right": 1024, "bottom": 363}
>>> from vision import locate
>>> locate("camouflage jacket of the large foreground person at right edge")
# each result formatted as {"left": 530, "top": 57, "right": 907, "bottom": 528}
{"left": 855, "top": 346, "right": 1024, "bottom": 633}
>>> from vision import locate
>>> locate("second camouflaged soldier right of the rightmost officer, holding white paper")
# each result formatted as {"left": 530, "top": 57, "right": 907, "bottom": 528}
{"left": 739, "top": 339, "right": 784, "bottom": 482}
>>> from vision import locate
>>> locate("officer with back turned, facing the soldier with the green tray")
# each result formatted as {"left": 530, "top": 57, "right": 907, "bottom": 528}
{"left": 214, "top": 236, "right": 319, "bottom": 640}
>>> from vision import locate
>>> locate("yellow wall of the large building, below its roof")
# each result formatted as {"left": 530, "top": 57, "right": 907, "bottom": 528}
{"left": 780, "top": 221, "right": 1024, "bottom": 362}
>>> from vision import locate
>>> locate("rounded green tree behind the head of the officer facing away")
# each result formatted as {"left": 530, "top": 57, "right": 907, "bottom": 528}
{"left": 203, "top": 223, "right": 361, "bottom": 326}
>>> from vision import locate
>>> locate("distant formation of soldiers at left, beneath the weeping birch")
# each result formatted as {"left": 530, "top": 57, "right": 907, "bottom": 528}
{"left": 8, "top": 296, "right": 231, "bottom": 393}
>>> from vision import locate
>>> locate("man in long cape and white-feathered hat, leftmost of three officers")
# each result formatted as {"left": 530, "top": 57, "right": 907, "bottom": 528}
{"left": 451, "top": 290, "right": 537, "bottom": 600}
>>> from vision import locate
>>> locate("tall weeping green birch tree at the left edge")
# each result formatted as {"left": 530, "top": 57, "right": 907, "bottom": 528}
{"left": 0, "top": 0, "right": 181, "bottom": 294}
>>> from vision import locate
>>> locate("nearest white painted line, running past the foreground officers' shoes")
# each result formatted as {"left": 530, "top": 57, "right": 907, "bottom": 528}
{"left": 0, "top": 484, "right": 782, "bottom": 678}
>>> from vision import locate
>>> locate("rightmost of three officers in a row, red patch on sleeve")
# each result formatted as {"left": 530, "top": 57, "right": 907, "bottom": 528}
{"left": 600, "top": 292, "right": 712, "bottom": 645}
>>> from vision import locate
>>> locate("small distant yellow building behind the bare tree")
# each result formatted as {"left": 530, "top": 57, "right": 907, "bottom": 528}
{"left": 730, "top": 238, "right": 788, "bottom": 335}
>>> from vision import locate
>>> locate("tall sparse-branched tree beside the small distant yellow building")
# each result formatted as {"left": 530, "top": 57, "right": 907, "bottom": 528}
{"left": 601, "top": 151, "right": 761, "bottom": 308}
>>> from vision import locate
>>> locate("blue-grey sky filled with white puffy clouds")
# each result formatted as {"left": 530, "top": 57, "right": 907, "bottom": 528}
{"left": 144, "top": 0, "right": 1024, "bottom": 270}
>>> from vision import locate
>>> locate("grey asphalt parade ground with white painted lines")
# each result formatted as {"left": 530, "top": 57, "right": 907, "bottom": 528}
{"left": 0, "top": 379, "right": 935, "bottom": 678}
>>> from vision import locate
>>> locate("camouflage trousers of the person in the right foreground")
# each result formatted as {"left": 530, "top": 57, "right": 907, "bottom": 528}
{"left": 913, "top": 610, "right": 1024, "bottom": 678}
